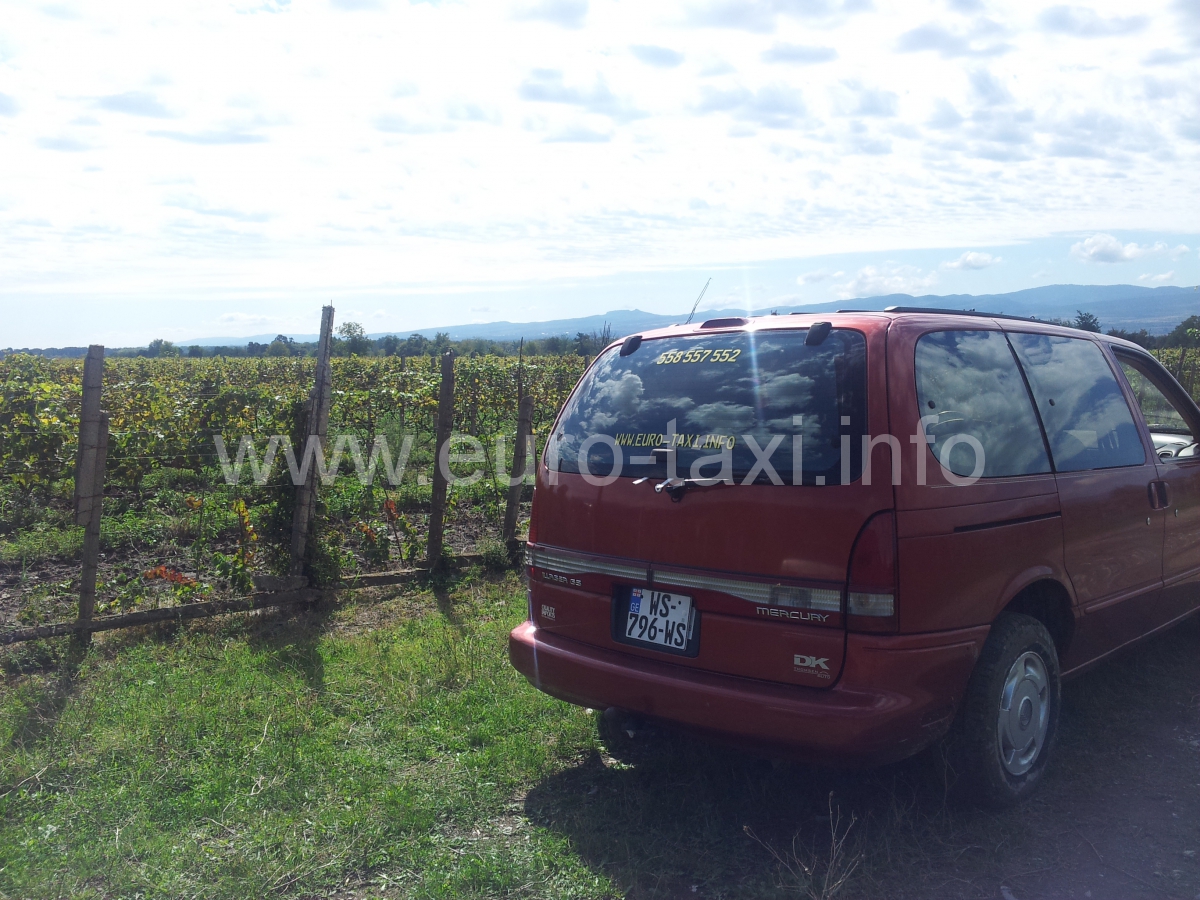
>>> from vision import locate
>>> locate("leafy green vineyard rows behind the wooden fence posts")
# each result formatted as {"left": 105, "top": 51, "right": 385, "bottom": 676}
{"left": 0, "top": 355, "right": 586, "bottom": 628}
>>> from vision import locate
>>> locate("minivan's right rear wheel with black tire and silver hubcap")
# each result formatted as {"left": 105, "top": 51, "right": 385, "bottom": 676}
{"left": 952, "top": 612, "right": 1062, "bottom": 809}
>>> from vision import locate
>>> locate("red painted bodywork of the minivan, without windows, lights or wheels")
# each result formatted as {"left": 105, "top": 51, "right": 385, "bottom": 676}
{"left": 510, "top": 313, "right": 1200, "bottom": 763}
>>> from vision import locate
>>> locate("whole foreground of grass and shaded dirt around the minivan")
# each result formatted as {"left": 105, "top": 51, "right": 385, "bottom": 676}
{"left": 0, "top": 571, "right": 1200, "bottom": 900}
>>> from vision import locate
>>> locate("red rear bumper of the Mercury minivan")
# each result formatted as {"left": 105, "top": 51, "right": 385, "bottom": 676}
{"left": 509, "top": 622, "right": 988, "bottom": 764}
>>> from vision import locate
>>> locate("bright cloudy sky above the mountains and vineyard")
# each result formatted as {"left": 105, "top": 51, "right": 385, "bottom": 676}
{"left": 0, "top": 0, "right": 1200, "bottom": 347}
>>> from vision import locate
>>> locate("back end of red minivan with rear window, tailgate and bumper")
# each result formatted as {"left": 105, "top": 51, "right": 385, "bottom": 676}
{"left": 510, "top": 313, "right": 986, "bottom": 762}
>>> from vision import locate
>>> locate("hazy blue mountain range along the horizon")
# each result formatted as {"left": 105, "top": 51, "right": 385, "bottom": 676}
{"left": 178, "top": 284, "right": 1200, "bottom": 347}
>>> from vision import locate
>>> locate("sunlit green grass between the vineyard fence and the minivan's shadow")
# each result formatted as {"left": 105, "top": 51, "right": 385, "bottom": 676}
{"left": 0, "top": 580, "right": 611, "bottom": 898}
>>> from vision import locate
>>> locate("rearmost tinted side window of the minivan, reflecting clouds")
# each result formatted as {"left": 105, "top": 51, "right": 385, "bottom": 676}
{"left": 917, "top": 331, "right": 1050, "bottom": 478}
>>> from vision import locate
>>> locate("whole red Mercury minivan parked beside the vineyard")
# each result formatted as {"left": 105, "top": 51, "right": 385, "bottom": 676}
{"left": 509, "top": 307, "right": 1200, "bottom": 804}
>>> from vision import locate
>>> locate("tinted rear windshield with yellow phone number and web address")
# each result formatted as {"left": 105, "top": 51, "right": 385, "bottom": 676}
{"left": 547, "top": 329, "right": 866, "bottom": 485}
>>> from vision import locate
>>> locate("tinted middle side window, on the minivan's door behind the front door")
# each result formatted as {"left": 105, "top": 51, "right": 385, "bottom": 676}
{"left": 1008, "top": 334, "right": 1146, "bottom": 472}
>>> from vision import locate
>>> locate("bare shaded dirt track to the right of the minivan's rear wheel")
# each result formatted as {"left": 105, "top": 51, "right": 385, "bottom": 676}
{"left": 974, "top": 617, "right": 1200, "bottom": 900}
